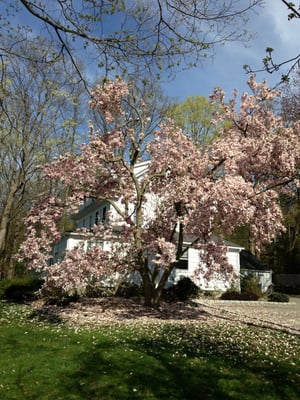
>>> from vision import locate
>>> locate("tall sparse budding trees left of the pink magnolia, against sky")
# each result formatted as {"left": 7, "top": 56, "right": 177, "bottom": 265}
{"left": 0, "top": 34, "right": 86, "bottom": 278}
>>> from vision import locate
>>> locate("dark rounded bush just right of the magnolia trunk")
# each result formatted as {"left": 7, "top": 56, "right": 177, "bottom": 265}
{"left": 162, "top": 277, "right": 200, "bottom": 302}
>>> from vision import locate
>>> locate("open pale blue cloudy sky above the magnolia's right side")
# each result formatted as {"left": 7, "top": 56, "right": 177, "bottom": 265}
{"left": 163, "top": 0, "right": 300, "bottom": 101}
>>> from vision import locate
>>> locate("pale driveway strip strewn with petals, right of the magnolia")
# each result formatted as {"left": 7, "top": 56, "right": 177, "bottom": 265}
{"left": 198, "top": 296, "right": 300, "bottom": 335}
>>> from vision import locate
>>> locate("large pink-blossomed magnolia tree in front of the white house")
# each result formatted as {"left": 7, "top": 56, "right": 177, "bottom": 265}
{"left": 20, "top": 78, "right": 300, "bottom": 306}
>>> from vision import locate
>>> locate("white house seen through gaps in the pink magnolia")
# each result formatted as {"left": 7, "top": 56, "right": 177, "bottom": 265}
{"left": 52, "top": 162, "right": 243, "bottom": 291}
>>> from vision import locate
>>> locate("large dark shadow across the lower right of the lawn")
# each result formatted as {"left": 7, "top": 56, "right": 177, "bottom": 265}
{"left": 58, "top": 327, "right": 300, "bottom": 400}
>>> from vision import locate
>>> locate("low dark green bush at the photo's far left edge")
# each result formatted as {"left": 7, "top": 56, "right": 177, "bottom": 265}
{"left": 0, "top": 277, "right": 43, "bottom": 302}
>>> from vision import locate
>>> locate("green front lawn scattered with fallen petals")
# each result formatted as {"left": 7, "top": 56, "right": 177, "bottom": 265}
{"left": 0, "top": 303, "right": 300, "bottom": 400}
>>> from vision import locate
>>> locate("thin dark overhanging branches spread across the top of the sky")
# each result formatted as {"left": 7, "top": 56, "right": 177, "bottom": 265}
{"left": 2, "top": 0, "right": 263, "bottom": 85}
